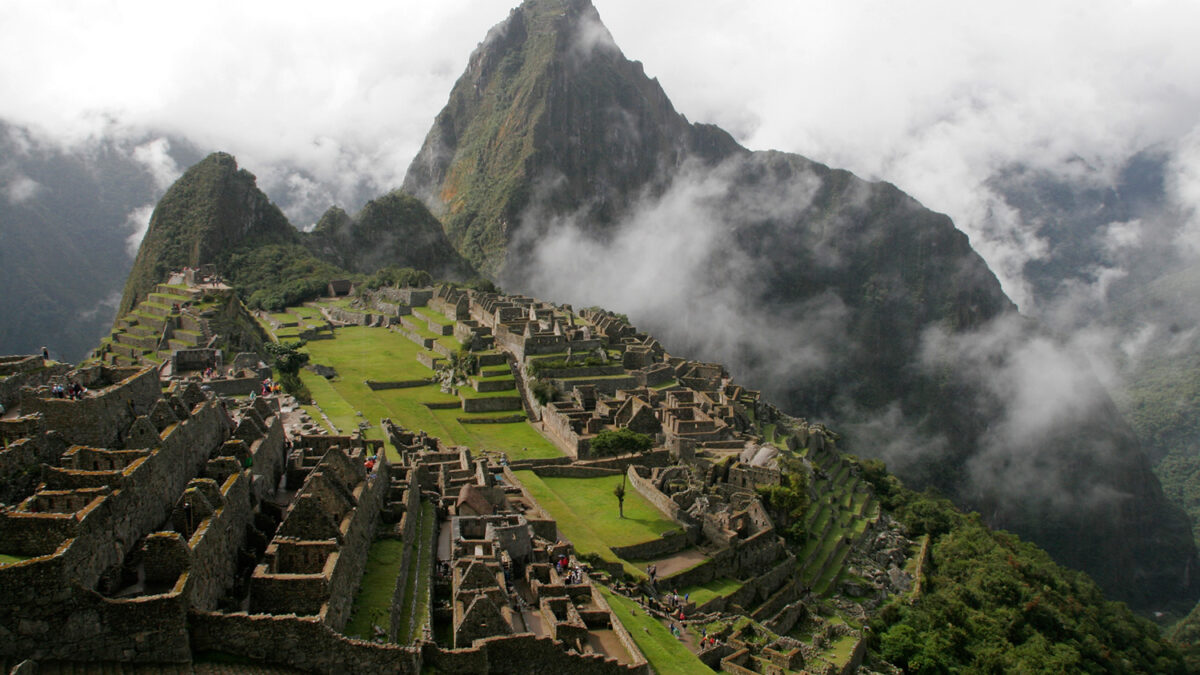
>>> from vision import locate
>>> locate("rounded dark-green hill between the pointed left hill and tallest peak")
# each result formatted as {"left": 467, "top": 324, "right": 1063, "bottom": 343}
{"left": 304, "top": 190, "right": 475, "bottom": 280}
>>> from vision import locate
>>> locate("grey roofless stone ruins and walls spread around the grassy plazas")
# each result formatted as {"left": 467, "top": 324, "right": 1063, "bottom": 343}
{"left": 0, "top": 281, "right": 919, "bottom": 673}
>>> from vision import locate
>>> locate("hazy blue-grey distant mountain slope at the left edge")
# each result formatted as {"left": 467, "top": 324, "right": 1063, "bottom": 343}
{"left": 0, "top": 121, "right": 199, "bottom": 360}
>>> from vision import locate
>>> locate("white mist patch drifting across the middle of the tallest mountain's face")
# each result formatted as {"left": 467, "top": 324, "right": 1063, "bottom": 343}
{"left": 513, "top": 157, "right": 847, "bottom": 386}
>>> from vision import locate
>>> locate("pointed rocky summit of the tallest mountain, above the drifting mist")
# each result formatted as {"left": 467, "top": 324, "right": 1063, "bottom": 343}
{"left": 403, "top": 0, "right": 740, "bottom": 275}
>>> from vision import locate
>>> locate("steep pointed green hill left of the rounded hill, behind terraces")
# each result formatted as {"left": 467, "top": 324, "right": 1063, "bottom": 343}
{"left": 118, "top": 153, "right": 300, "bottom": 313}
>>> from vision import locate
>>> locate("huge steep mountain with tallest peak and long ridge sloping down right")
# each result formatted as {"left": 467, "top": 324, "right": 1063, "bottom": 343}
{"left": 404, "top": 0, "right": 1200, "bottom": 608}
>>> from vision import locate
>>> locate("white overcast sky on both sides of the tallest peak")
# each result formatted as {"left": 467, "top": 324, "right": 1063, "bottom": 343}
{"left": 0, "top": 0, "right": 1200, "bottom": 300}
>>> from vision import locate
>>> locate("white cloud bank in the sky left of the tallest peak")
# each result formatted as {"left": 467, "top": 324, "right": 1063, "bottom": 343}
{"left": 0, "top": 0, "right": 508, "bottom": 199}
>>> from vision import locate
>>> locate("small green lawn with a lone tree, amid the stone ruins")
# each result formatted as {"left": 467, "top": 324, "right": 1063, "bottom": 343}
{"left": 516, "top": 471, "right": 680, "bottom": 578}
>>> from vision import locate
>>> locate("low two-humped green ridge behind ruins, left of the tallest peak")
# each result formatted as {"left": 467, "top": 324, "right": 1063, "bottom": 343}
{"left": 121, "top": 153, "right": 475, "bottom": 311}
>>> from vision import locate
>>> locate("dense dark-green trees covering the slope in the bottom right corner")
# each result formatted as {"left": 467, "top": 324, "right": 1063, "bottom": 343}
{"left": 863, "top": 461, "right": 1184, "bottom": 673}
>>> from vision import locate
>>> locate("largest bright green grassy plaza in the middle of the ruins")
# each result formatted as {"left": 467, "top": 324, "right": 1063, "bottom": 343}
{"left": 260, "top": 300, "right": 562, "bottom": 460}
